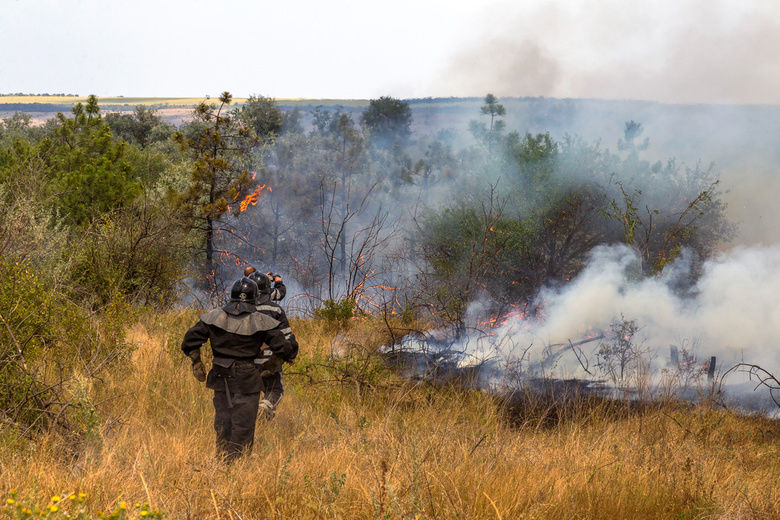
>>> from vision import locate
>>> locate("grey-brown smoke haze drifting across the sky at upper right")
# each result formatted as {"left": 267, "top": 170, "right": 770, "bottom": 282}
{"left": 432, "top": 0, "right": 780, "bottom": 104}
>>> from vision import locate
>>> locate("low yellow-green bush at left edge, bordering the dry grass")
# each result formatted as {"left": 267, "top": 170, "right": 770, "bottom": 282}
{"left": 0, "top": 258, "right": 132, "bottom": 433}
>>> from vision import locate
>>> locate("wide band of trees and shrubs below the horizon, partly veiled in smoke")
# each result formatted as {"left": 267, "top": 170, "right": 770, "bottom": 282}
{"left": 0, "top": 93, "right": 731, "bottom": 323}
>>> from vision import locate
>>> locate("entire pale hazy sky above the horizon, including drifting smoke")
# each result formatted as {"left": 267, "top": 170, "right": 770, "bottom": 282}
{"left": 0, "top": 0, "right": 780, "bottom": 104}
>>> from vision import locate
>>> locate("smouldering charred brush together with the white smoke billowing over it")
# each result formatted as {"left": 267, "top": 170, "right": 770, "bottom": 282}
{"left": 384, "top": 246, "right": 780, "bottom": 413}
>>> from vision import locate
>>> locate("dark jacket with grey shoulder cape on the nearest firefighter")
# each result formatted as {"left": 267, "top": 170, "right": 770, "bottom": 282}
{"left": 181, "top": 304, "right": 297, "bottom": 393}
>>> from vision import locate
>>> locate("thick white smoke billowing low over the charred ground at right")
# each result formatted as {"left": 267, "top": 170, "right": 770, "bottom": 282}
{"left": 453, "top": 245, "right": 780, "bottom": 386}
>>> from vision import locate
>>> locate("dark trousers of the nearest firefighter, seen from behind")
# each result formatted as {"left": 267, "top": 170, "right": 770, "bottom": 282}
{"left": 214, "top": 391, "right": 260, "bottom": 462}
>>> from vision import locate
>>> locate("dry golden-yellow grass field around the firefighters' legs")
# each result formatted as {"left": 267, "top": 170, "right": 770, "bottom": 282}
{"left": 0, "top": 313, "right": 780, "bottom": 519}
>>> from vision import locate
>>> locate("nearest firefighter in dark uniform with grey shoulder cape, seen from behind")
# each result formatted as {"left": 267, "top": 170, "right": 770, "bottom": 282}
{"left": 181, "top": 277, "right": 295, "bottom": 462}
